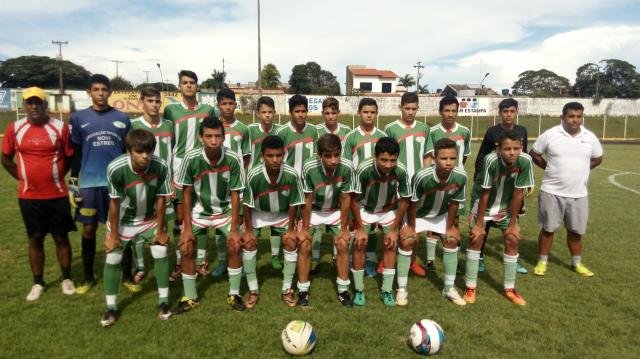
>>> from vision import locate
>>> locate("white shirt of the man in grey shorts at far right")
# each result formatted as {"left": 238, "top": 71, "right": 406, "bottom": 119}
{"left": 532, "top": 125, "right": 602, "bottom": 198}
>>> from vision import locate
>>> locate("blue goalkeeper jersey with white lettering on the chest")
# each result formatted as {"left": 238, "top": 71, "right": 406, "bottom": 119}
{"left": 69, "top": 107, "right": 131, "bottom": 188}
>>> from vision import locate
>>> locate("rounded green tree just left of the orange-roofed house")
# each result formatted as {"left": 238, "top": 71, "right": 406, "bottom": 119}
{"left": 289, "top": 61, "right": 340, "bottom": 95}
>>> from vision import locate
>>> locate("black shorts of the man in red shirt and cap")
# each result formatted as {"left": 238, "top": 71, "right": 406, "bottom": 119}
{"left": 18, "top": 197, "right": 77, "bottom": 237}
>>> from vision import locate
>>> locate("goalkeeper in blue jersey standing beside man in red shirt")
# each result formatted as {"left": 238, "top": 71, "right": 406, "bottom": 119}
{"left": 69, "top": 74, "right": 131, "bottom": 294}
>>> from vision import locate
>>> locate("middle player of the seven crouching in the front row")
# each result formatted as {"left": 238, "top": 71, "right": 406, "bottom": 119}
{"left": 298, "top": 133, "right": 353, "bottom": 307}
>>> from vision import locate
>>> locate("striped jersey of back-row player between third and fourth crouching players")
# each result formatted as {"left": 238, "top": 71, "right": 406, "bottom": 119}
{"left": 276, "top": 121, "right": 318, "bottom": 176}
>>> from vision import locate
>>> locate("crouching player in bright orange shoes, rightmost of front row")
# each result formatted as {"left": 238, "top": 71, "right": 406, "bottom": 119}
{"left": 463, "top": 132, "right": 534, "bottom": 305}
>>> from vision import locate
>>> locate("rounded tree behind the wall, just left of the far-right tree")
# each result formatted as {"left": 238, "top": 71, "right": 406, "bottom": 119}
{"left": 512, "top": 69, "right": 571, "bottom": 97}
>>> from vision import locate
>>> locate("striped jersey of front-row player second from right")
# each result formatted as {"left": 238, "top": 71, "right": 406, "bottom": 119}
{"left": 411, "top": 166, "right": 467, "bottom": 218}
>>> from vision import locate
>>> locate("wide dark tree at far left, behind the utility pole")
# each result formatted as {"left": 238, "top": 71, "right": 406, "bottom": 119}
{"left": 0, "top": 55, "right": 91, "bottom": 89}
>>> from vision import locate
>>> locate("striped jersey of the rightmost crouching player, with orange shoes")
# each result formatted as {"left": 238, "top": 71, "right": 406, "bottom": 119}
{"left": 472, "top": 151, "right": 535, "bottom": 220}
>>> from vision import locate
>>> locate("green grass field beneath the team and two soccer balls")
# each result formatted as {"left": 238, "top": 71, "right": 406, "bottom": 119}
{"left": 0, "top": 112, "right": 640, "bottom": 358}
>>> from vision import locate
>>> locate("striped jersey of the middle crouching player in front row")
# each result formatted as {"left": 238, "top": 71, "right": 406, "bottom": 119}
{"left": 302, "top": 156, "right": 353, "bottom": 212}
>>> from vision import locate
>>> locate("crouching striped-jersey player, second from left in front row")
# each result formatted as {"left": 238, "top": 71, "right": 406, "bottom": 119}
{"left": 175, "top": 116, "right": 245, "bottom": 314}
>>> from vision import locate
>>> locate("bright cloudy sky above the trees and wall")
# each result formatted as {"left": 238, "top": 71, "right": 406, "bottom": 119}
{"left": 0, "top": 0, "right": 640, "bottom": 91}
